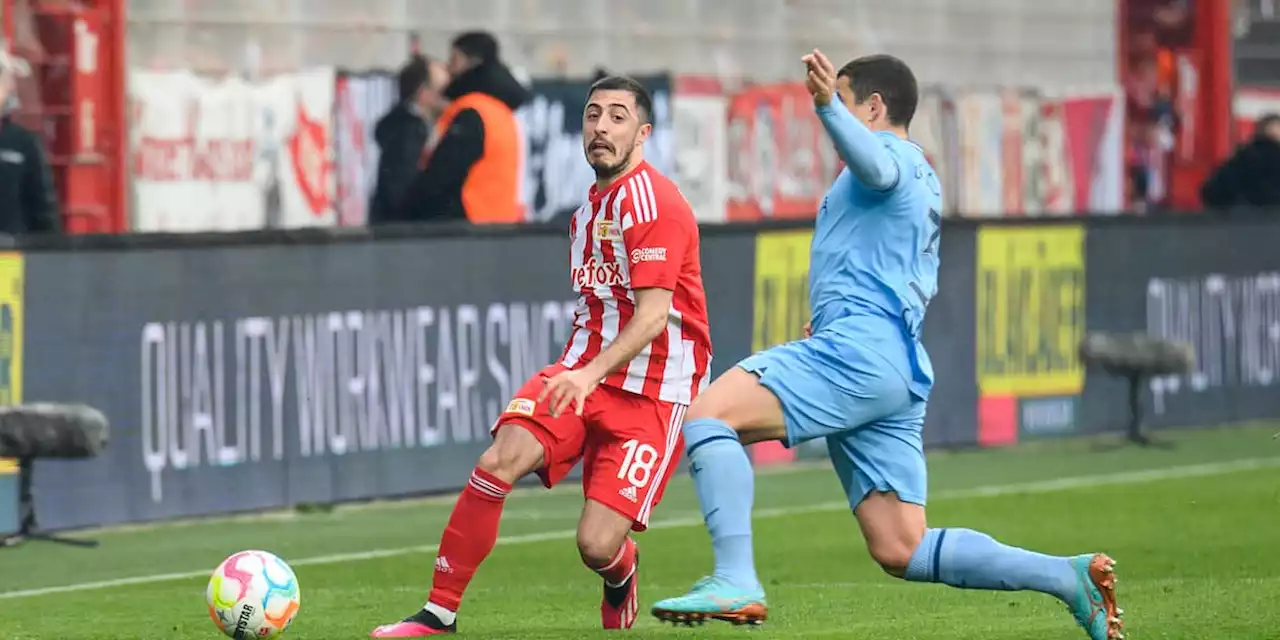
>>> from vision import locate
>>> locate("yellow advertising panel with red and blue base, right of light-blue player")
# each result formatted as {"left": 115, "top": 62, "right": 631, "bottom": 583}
{"left": 977, "top": 225, "right": 1085, "bottom": 444}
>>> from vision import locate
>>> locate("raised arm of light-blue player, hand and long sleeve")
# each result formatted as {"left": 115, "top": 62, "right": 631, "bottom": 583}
{"left": 804, "top": 49, "right": 899, "bottom": 191}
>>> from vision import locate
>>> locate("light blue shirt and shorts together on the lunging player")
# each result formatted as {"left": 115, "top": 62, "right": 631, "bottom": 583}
{"left": 739, "top": 101, "right": 942, "bottom": 506}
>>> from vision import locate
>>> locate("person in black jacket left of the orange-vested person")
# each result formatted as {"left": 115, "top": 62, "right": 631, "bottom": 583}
{"left": 369, "top": 55, "right": 449, "bottom": 224}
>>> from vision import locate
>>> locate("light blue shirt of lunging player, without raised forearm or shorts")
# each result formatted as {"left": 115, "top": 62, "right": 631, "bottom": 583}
{"left": 809, "top": 129, "right": 942, "bottom": 399}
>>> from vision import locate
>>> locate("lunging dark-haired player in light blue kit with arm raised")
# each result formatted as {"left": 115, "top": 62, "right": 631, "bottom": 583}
{"left": 653, "top": 50, "right": 1124, "bottom": 640}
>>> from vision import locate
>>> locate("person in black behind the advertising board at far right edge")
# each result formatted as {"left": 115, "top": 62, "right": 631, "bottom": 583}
{"left": 1201, "top": 114, "right": 1280, "bottom": 209}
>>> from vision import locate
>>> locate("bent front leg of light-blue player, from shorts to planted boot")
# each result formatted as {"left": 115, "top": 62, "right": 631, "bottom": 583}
{"left": 653, "top": 334, "right": 906, "bottom": 625}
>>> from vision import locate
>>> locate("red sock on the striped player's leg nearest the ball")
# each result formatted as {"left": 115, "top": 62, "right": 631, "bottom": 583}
{"left": 428, "top": 468, "right": 512, "bottom": 612}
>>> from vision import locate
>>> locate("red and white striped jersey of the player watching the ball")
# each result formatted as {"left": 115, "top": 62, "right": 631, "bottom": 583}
{"left": 561, "top": 163, "right": 712, "bottom": 404}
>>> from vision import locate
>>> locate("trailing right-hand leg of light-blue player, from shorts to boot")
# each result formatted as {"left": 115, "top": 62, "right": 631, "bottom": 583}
{"left": 827, "top": 414, "right": 1124, "bottom": 640}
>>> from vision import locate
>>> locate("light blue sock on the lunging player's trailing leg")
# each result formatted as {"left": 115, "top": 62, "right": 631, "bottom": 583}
{"left": 905, "top": 529, "right": 1079, "bottom": 600}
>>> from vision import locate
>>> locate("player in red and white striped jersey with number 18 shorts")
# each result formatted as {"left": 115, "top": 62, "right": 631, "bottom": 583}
{"left": 372, "top": 77, "right": 712, "bottom": 637}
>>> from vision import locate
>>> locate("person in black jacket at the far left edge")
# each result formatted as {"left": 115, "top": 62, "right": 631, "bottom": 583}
{"left": 0, "top": 50, "right": 61, "bottom": 236}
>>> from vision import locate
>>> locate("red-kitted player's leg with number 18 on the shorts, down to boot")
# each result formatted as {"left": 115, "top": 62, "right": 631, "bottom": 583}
{"left": 577, "top": 387, "right": 687, "bottom": 628}
